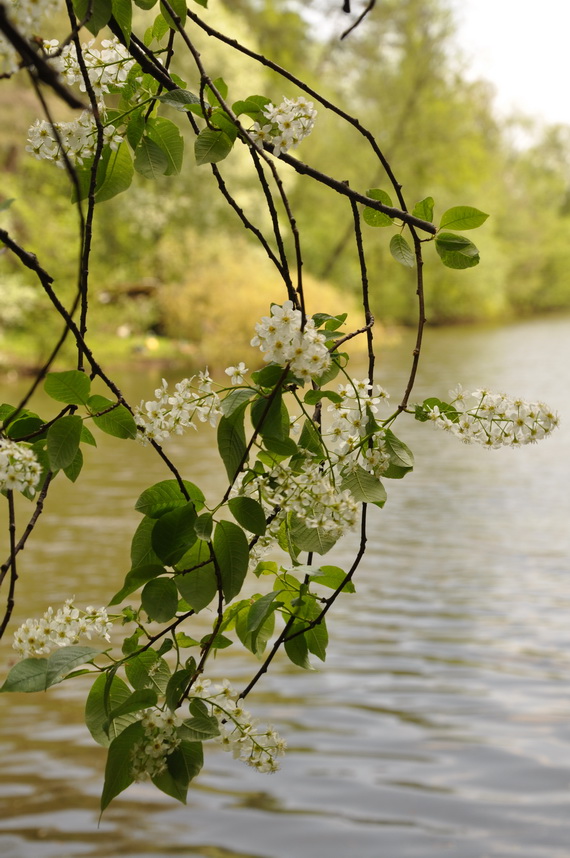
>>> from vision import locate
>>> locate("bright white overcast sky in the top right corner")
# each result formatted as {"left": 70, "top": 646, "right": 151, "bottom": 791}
{"left": 453, "top": 0, "right": 570, "bottom": 124}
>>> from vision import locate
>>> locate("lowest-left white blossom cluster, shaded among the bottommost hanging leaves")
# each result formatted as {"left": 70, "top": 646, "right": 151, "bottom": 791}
{"left": 131, "top": 708, "right": 182, "bottom": 781}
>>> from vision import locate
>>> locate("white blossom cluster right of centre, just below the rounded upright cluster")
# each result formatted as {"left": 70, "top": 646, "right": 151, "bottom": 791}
{"left": 324, "top": 378, "right": 390, "bottom": 477}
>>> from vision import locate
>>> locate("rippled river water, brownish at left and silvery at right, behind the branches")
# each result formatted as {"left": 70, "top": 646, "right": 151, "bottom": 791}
{"left": 0, "top": 318, "right": 570, "bottom": 858}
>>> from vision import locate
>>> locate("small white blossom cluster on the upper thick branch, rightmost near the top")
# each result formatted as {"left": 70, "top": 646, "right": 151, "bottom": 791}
{"left": 249, "top": 96, "right": 317, "bottom": 154}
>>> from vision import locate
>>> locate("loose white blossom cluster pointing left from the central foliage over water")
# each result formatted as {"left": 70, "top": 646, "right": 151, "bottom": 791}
{"left": 134, "top": 370, "right": 222, "bottom": 444}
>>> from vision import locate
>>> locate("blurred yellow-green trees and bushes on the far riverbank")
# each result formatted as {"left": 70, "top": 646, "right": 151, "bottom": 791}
{"left": 0, "top": 0, "right": 570, "bottom": 365}
